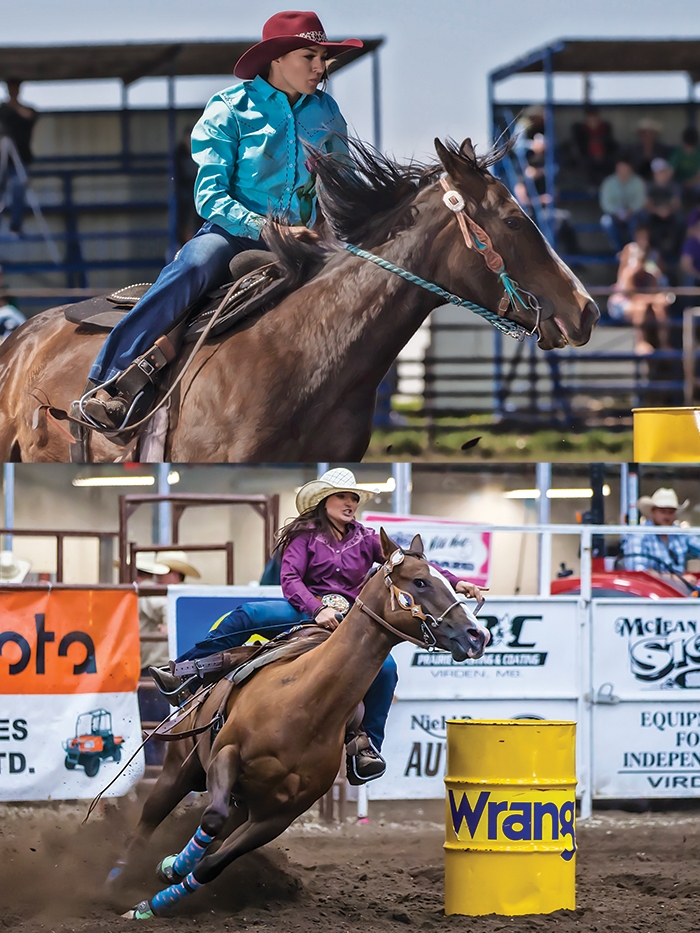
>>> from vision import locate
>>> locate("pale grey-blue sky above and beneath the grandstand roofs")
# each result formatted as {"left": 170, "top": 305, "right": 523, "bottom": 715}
{"left": 0, "top": 0, "right": 700, "bottom": 157}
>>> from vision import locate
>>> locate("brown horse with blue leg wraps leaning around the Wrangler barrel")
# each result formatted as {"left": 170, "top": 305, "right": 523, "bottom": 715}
{"left": 112, "top": 529, "right": 488, "bottom": 919}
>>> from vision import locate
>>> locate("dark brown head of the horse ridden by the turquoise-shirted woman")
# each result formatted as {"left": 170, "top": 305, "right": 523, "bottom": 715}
{"left": 435, "top": 139, "right": 600, "bottom": 350}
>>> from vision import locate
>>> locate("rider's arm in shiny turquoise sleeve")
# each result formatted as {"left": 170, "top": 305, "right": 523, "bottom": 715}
{"left": 192, "top": 94, "right": 266, "bottom": 240}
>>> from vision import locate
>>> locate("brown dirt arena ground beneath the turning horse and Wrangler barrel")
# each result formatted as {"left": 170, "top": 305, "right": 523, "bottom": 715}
{"left": 0, "top": 801, "right": 700, "bottom": 933}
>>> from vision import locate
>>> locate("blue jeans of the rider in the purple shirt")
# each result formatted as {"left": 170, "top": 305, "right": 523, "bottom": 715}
{"left": 177, "top": 599, "right": 399, "bottom": 751}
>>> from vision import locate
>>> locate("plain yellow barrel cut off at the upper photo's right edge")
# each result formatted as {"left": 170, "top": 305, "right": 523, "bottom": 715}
{"left": 632, "top": 408, "right": 700, "bottom": 463}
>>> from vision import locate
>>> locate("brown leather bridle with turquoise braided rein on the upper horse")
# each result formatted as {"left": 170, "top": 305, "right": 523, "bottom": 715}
{"left": 344, "top": 173, "right": 542, "bottom": 341}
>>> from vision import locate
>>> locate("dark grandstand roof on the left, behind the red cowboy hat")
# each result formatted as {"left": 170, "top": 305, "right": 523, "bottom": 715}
{"left": 0, "top": 39, "right": 383, "bottom": 84}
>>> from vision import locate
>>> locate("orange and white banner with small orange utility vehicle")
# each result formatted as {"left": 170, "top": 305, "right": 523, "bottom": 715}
{"left": 0, "top": 588, "right": 144, "bottom": 800}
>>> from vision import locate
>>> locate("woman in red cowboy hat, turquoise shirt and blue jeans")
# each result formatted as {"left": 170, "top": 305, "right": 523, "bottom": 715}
{"left": 83, "top": 11, "right": 362, "bottom": 428}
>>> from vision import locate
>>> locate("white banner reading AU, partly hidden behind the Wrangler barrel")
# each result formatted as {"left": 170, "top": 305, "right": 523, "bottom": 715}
{"left": 369, "top": 698, "right": 577, "bottom": 800}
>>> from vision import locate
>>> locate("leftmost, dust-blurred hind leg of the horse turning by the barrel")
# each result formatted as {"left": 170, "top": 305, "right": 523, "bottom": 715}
{"left": 107, "top": 742, "right": 203, "bottom": 883}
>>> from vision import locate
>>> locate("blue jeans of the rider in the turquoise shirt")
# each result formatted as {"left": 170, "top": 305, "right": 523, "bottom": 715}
{"left": 90, "top": 221, "right": 267, "bottom": 382}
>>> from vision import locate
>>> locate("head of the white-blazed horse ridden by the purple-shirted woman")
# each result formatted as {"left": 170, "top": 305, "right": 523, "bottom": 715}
{"left": 359, "top": 528, "right": 489, "bottom": 661}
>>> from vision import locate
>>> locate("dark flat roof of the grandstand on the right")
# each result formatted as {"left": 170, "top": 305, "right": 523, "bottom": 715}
{"left": 491, "top": 38, "right": 700, "bottom": 82}
